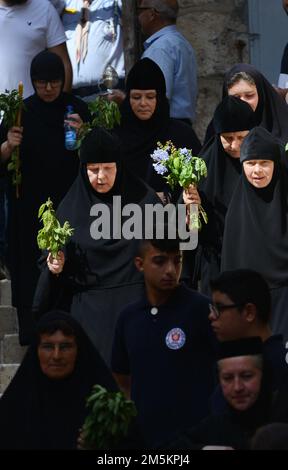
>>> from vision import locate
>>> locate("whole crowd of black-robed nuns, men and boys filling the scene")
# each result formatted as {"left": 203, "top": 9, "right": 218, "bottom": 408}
{"left": 0, "top": 0, "right": 288, "bottom": 450}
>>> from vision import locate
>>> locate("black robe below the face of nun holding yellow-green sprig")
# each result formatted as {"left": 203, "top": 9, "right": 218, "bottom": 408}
{"left": 34, "top": 165, "right": 160, "bottom": 362}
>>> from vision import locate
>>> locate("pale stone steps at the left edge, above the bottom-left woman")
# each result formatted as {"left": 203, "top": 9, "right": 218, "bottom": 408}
{"left": 0, "top": 279, "right": 26, "bottom": 395}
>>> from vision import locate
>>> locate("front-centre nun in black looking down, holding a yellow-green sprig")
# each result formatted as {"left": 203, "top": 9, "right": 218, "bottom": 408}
{"left": 34, "top": 128, "right": 161, "bottom": 362}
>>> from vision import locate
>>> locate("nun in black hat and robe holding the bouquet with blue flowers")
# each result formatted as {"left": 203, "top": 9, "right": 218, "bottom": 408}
{"left": 183, "top": 96, "right": 255, "bottom": 294}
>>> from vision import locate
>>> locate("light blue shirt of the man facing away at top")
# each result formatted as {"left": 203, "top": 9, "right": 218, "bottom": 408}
{"left": 142, "top": 25, "right": 197, "bottom": 121}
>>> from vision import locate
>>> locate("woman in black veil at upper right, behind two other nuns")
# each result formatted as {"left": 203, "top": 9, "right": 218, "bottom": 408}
{"left": 205, "top": 63, "right": 288, "bottom": 143}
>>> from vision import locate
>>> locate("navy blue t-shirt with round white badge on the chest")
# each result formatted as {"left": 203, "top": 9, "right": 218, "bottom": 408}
{"left": 112, "top": 285, "right": 215, "bottom": 447}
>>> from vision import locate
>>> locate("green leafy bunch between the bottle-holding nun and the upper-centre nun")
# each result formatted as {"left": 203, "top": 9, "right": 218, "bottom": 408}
{"left": 78, "top": 96, "right": 121, "bottom": 147}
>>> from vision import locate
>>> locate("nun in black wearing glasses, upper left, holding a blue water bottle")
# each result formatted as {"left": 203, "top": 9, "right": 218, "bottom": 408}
{"left": 0, "top": 51, "right": 89, "bottom": 344}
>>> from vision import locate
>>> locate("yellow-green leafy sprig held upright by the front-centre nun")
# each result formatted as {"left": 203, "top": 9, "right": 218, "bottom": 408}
{"left": 37, "top": 197, "right": 74, "bottom": 257}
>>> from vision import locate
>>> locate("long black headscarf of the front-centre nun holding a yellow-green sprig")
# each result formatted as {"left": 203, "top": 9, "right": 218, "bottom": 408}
{"left": 57, "top": 128, "right": 160, "bottom": 289}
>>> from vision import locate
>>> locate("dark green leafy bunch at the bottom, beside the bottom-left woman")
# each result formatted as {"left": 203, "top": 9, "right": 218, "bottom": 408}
{"left": 83, "top": 385, "right": 137, "bottom": 449}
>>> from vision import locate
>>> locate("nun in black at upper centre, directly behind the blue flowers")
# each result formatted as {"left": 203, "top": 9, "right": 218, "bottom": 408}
{"left": 115, "top": 58, "right": 201, "bottom": 199}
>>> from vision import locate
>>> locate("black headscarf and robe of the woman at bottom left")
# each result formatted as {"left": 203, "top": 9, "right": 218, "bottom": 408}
{"left": 0, "top": 311, "right": 117, "bottom": 450}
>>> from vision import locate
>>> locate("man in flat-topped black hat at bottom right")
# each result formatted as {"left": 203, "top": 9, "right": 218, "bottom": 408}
{"left": 161, "top": 337, "right": 272, "bottom": 450}
